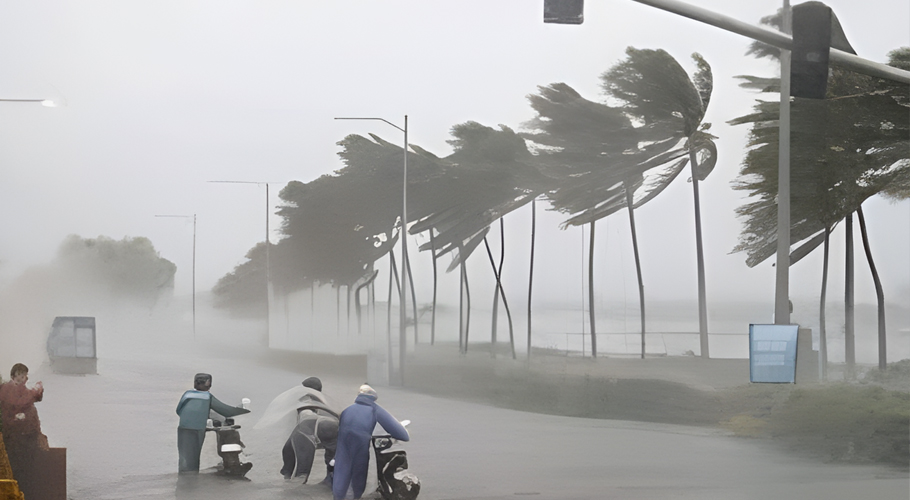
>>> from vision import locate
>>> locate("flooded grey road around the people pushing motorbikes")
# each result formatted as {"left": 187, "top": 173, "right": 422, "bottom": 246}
{"left": 31, "top": 320, "right": 910, "bottom": 500}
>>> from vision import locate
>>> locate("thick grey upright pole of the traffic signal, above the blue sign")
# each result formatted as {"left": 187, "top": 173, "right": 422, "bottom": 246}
{"left": 774, "top": 0, "right": 792, "bottom": 325}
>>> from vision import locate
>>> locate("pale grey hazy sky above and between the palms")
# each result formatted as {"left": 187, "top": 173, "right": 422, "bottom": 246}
{"left": 0, "top": 0, "right": 910, "bottom": 307}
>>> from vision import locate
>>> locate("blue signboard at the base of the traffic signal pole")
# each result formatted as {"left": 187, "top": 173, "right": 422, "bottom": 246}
{"left": 749, "top": 325, "right": 799, "bottom": 384}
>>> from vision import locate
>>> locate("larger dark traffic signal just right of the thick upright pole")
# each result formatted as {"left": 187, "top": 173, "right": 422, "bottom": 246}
{"left": 790, "top": 2, "right": 834, "bottom": 99}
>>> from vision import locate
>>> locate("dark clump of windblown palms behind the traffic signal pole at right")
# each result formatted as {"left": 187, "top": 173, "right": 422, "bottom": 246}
{"left": 730, "top": 49, "right": 910, "bottom": 369}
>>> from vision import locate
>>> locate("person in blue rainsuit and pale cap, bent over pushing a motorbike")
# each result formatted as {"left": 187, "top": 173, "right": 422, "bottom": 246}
{"left": 332, "top": 384, "right": 410, "bottom": 500}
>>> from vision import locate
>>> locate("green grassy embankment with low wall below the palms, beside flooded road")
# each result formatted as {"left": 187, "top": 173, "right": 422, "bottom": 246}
{"left": 406, "top": 351, "right": 910, "bottom": 468}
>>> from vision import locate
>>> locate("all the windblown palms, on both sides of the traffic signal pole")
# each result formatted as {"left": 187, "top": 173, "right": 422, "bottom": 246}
{"left": 217, "top": 40, "right": 910, "bottom": 368}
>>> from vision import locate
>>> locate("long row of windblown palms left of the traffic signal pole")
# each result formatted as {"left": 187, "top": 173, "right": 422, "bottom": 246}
{"left": 228, "top": 47, "right": 716, "bottom": 357}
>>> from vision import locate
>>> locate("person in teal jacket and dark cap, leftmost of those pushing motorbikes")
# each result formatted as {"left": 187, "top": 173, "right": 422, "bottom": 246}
{"left": 177, "top": 373, "right": 250, "bottom": 473}
